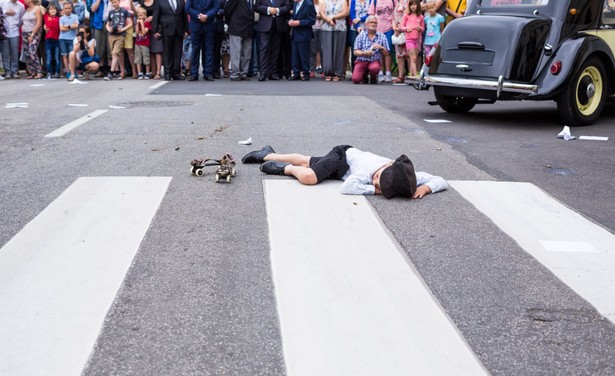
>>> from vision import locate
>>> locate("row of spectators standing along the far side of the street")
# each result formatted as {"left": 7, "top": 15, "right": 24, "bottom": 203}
{"left": 0, "top": 0, "right": 467, "bottom": 83}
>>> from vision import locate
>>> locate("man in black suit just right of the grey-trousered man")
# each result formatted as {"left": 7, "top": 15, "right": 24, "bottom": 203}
{"left": 254, "top": 0, "right": 291, "bottom": 81}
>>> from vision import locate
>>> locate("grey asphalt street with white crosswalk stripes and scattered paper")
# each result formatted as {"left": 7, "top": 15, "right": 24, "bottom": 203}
{"left": 0, "top": 80, "right": 615, "bottom": 376}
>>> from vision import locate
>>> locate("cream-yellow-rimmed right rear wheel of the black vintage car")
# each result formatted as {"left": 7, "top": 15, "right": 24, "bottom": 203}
{"left": 557, "top": 57, "right": 607, "bottom": 126}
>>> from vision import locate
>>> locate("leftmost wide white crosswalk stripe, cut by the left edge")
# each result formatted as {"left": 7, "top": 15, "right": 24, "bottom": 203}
{"left": 0, "top": 177, "right": 171, "bottom": 376}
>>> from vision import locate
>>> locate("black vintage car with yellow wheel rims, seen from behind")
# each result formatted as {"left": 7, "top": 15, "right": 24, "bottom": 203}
{"left": 409, "top": 0, "right": 615, "bottom": 126}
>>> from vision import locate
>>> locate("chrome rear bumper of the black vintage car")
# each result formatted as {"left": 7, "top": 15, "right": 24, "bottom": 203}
{"left": 407, "top": 72, "right": 538, "bottom": 93}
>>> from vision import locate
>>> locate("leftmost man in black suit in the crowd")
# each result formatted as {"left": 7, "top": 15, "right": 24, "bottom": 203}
{"left": 152, "top": 0, "right": 188, "bottom": 81}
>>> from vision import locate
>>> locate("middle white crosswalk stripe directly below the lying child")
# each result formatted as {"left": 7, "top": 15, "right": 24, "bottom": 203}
{"left": 264, "top": 180, "right": 485, "bottom": 376}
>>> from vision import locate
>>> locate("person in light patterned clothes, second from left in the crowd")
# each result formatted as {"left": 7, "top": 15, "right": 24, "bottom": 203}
{"left": 21, "top": 0, "right": 43, "bottom": 79}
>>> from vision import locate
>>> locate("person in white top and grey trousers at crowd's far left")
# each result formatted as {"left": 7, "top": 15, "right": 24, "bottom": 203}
{"left": 0, "top": 0, "right": 26, "bottom": 78}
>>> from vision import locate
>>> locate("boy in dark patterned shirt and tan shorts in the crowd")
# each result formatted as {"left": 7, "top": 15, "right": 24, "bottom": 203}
{"left": 105, "top": 0, "right": 132, "bottom": 81}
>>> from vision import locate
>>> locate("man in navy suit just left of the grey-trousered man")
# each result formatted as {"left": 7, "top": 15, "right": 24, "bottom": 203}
{"left": 185, "top": 0, "right": 218, "bottom": 81}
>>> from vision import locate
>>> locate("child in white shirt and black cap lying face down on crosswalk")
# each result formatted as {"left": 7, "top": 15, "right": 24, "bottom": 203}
{"left": 241, "top": 145, "right": 448, "bottom": 199}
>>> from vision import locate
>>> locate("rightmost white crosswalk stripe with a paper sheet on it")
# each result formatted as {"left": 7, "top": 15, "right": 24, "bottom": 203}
{"left": 449, "top": 181, "right": 615, "bottom": 322}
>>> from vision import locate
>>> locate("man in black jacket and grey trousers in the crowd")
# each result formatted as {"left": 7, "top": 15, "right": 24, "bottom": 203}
{"left": 225, "top": 0, "right": 254, "bottom": 81}
